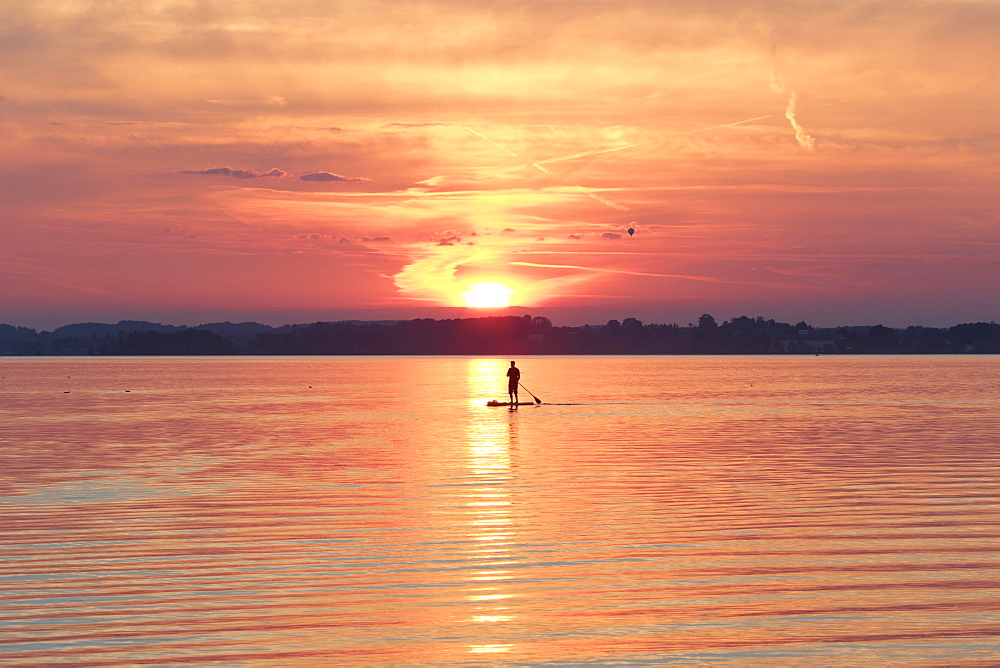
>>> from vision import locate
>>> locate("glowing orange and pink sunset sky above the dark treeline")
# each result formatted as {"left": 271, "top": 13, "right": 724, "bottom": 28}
{"left": 0, "top": 0, "right": 1000, "bottom": 328}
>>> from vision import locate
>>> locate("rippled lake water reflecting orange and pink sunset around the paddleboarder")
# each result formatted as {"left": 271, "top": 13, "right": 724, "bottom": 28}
{"left": 0, "top": 356, "right": 1000, "bottom": 665}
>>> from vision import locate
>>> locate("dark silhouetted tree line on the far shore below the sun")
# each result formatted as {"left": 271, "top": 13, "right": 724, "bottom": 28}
{"left": 0, "top": 314, "right": 1000, "bottom": 356}
